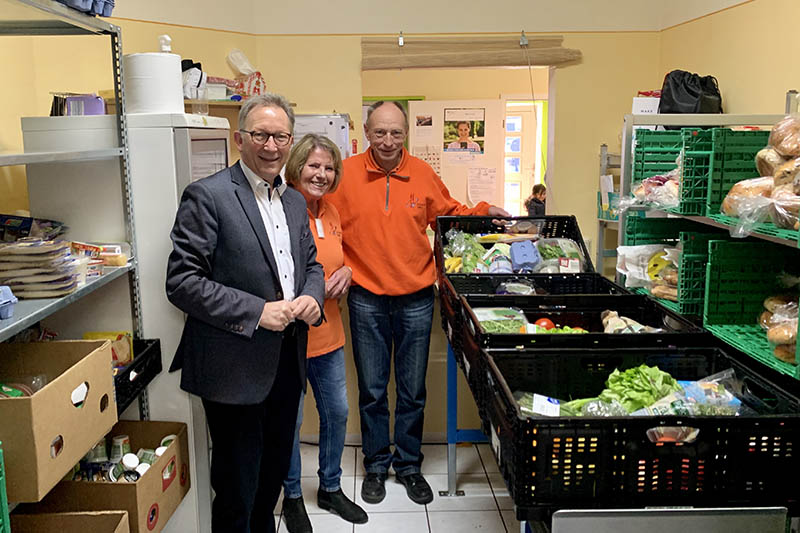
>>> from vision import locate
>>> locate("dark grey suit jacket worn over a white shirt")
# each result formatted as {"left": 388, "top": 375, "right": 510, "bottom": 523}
{"left": 167, "top": 163, "right": 325, "bottom": 405}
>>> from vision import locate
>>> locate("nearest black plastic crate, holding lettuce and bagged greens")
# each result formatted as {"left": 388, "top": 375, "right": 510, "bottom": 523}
{"left": 483, "top": 347, "right": 800, "bottom": 520}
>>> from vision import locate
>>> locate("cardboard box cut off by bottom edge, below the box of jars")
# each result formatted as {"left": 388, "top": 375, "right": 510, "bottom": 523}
{"left": 11, "top": 511, "right": 131, "bottom": 533}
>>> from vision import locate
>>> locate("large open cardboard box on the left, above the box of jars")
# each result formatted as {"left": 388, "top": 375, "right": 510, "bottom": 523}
{"left": 0, "top": 340, "right": 117, "bottom": 502}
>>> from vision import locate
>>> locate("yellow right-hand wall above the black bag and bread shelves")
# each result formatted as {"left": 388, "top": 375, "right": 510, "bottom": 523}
{"left": 661, "top": 0, "right": 800, "bottom": 113}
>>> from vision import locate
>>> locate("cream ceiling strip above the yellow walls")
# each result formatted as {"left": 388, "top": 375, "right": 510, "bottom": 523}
{"left": 114, "top": 0, "right": 752, "bottom": 34}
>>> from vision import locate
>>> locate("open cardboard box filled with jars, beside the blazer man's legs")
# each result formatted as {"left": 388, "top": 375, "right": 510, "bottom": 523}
{"left": 15, "top": 420, "right": 191, "bottom": 533}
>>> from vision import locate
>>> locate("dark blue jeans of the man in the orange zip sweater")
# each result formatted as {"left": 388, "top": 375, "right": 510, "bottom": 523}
{"left": 347, "top": 286, "right": 433, "bottom": 475}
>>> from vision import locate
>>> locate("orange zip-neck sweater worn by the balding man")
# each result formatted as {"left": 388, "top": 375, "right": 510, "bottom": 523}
{"left": 326, "top": 149, "right": 489, "bottom": 296}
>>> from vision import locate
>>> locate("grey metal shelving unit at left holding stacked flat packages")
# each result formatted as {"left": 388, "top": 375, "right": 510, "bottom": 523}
{"left": 0, "top": 0, "right": 149, "bottom": 412}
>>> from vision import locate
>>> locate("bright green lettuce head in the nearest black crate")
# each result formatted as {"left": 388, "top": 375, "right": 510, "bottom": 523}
{"left": 599, "top": 365, "right": 681, "bottom": 413}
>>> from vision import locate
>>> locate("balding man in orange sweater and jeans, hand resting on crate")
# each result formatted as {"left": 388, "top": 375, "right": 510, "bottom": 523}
{"left": 330, "top": 102, "right": 508, "bottom": 504}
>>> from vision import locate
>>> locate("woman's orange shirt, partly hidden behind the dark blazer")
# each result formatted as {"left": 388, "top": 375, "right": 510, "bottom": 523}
{"left": 306, "top": 198, "right": 344, "bottom": 357}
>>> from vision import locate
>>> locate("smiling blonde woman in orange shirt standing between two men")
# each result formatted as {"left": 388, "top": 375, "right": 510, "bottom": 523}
{"left": 283, "top": 133, "right": 368, "bottom": 533}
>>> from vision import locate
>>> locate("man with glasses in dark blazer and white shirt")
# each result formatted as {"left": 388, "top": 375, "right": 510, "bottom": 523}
{"left": 167, "top": 94, "right": 325, "bottom": 533}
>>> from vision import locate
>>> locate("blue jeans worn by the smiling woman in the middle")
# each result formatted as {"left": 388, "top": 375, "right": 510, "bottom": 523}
{"left": 283, "top": 348, "right": 348, "bottom": 498}
